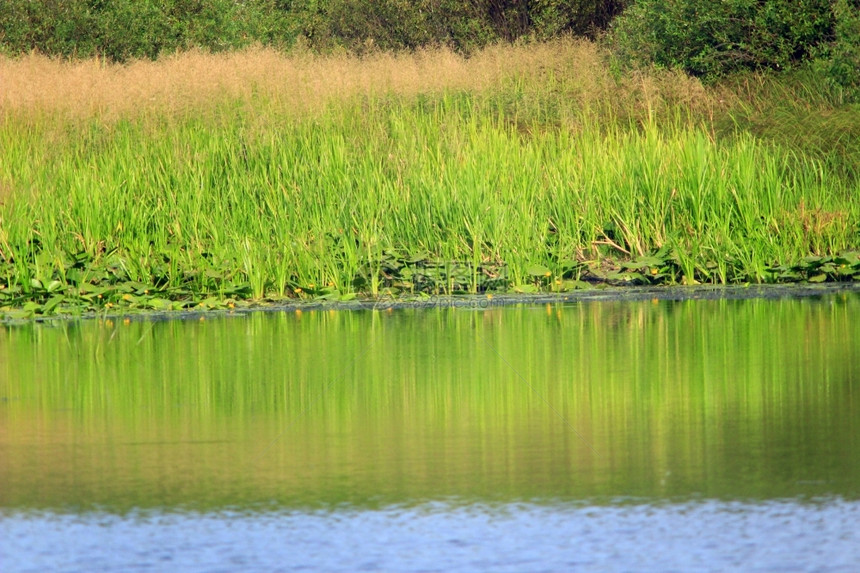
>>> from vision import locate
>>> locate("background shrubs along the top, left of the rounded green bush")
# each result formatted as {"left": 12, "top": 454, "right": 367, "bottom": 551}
{"left": 0, "top": 0, "right": 628, "bottom": 61}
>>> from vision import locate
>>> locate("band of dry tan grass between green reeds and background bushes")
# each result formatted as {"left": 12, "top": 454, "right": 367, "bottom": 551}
{"left": 0, "top": 39, "right": 704, "bottom": 120}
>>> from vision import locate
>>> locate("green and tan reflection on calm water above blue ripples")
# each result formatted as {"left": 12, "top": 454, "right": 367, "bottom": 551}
{"left": 0, "top": 294, "right": 860, "bottom": 511}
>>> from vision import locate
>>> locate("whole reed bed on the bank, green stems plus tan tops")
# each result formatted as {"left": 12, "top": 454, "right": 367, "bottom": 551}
{"left": 0, "top": 40, "right": 860, "bottom": 314}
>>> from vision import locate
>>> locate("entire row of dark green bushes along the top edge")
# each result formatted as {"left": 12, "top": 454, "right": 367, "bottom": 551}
{"left": 0, "top": 0, "right": 860, "bottom": 73}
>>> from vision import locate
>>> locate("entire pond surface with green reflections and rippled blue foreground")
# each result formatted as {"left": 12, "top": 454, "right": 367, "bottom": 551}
{"left": 0, "top": 292, "right": 860, "bottom": 572}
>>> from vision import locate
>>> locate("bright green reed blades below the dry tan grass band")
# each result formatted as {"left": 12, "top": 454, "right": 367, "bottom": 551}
{"left": 0, "top": 84, "right": 860, "bottom": 308}
